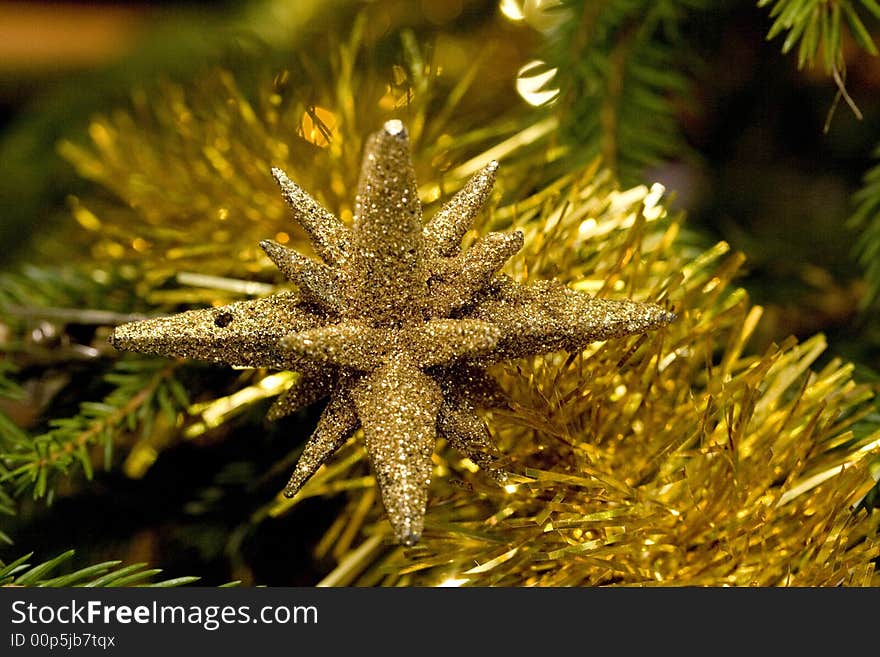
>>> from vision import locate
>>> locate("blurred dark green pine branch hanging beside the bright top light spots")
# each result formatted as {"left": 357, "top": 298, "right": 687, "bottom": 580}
{"left": 548, "top": 0, "right": 706, "bottom": 184}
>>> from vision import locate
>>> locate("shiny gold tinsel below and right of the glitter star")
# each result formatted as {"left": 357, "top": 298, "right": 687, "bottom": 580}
{"left": 267, "top": 169, "right": 880, "bottom": 586}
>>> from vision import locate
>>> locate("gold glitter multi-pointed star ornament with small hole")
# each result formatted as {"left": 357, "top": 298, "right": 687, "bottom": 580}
{"left": 111, "top": 120, "right": 674, "bottom": 545}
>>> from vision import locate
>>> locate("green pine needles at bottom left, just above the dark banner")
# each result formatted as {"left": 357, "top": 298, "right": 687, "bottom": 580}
{"left": 0, "top": 550, "right": 199, "bottom": 588}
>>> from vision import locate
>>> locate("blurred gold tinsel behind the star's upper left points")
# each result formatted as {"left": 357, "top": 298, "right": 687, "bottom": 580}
{"left": 60, "top": 16, "right": 536, "bottom": 290}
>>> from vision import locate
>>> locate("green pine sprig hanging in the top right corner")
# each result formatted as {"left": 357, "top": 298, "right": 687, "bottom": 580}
{"left": 758, "top": 0, "right": 880, "bottom": 75}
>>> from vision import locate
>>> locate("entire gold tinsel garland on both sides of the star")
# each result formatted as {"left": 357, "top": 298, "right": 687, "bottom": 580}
{"left": 46, "top": 25, "right": 880, "bottom": 586}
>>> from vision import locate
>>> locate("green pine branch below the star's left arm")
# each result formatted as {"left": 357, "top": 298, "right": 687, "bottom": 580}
{"left": 0, "top": 359, "right": 189, "bottom": 502}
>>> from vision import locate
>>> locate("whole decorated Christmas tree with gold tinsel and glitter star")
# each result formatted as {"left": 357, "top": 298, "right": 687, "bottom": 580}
{"left": 0, "top": 0, "right": 880, "bottom": 586}
